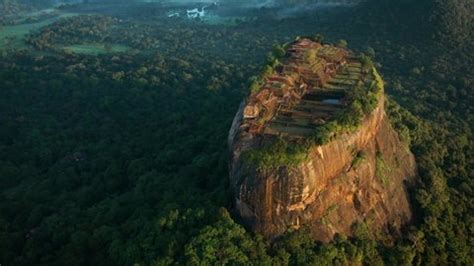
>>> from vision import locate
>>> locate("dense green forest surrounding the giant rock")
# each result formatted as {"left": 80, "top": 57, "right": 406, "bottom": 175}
{"left": 0, "top": 0, "right": 474, "bottom": 265}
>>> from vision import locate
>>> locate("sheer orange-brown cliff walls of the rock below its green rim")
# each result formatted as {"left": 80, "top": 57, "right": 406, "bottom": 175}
{"left": 229, "top": 97, "right": 416, "bottom": 241}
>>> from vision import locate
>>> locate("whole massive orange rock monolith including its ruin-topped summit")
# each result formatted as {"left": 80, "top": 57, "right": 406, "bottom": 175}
{"left": 229, "top": 39, "right": 416, "bottom": 241}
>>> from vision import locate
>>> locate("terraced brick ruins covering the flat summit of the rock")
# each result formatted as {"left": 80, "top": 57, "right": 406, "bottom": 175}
{"left": 243, "top": 38, "right": 374, "bottom": 139}
